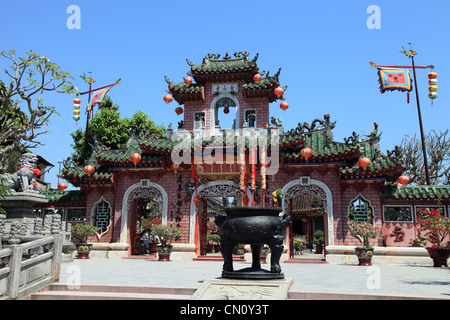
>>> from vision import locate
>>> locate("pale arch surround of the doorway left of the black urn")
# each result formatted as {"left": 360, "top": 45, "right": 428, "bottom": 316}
{"left": 120, "top": 179, "right": 168, "bottom": 243}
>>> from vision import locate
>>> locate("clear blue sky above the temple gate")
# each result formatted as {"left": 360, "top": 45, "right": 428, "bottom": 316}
{"left": 0, "top": 0, "right": 450, "bottom": 188}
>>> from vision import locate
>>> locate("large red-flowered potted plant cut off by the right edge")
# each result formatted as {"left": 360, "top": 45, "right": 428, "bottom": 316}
{"left": 417, "top": 208, "right": 450, "bottom": 267}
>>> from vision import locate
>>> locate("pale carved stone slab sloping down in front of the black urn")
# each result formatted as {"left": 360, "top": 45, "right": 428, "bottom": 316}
{"left": 192, "top": 279, "right": 294, "bottom": 300}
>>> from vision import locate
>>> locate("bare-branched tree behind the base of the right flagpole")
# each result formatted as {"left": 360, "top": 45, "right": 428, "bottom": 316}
{"left": 402, "top": 129, "right": 450, "bottom": 185}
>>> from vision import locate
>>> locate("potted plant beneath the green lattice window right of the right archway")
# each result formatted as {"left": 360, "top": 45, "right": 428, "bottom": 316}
{"left": 347, "top": 220, "right": 381, "bottom": 266}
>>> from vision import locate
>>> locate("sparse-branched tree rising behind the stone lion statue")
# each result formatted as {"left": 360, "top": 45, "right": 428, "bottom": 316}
{"left": 0, "top": 50, "right": 76, "bottom": 171}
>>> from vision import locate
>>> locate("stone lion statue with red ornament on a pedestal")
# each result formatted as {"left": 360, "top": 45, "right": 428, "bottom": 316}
{"left": 0, "top": 152, "right": 41, "bottom": 192}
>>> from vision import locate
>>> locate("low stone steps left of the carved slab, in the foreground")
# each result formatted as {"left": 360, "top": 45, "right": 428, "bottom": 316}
{"left": 29, "top": 283, "right": 196, "bottom": 300}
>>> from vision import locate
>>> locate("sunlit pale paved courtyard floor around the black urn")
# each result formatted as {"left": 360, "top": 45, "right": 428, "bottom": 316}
{"left": 60, "top": 259, "right": 450, "bottom": 299}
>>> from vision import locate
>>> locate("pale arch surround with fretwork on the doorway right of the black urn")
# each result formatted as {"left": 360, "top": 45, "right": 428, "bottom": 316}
{"left": 281, "top": 177, "right": 334, "bottom": 245}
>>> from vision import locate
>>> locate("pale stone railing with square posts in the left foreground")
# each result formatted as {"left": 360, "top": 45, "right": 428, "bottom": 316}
{"left": 0, "top": 233, "right": 64, "bottom": 300}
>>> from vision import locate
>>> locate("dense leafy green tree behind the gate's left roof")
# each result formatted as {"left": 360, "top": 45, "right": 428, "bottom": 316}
{"left": 71, "top": 97, "right": 165, "bottom": 163}
